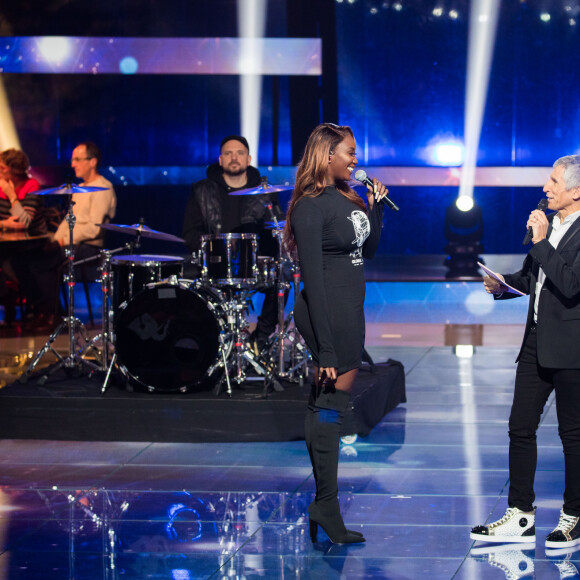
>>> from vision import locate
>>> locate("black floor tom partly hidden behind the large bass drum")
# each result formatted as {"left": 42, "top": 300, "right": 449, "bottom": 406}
{"left": 111, "top": 254, "right": 183, "bottom": 308}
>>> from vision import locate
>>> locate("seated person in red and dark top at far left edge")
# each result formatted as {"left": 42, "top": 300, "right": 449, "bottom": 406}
{"left": 0, "top": 148, "right": 46, "bottom": 324}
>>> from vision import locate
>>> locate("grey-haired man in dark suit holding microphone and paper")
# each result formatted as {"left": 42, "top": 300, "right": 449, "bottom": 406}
{"left": 470, "top": 155, "right": 580, "bottom": 548}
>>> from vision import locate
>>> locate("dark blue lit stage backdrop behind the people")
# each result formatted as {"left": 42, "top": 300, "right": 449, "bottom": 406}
{"left": 0, "top": 0, "right": 580, "bottom": 254}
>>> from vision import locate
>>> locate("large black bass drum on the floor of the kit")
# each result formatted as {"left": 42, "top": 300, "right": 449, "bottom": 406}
{"left": 115, "top": 283, "right": 224, "bottom": 393}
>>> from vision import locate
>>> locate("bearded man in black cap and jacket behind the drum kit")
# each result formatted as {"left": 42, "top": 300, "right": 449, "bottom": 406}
{"left": 182, "top": 135, "right": 284, "bottom": 350}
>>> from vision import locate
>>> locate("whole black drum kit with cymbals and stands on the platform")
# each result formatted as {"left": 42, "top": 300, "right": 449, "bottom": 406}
{"left": 20, "top": 183, "right": 309, "bottom": 396}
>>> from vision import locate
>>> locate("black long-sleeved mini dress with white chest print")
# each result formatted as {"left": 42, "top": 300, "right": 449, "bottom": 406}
{"left": 291, "top": 186, "right": 383, "bottom": 374}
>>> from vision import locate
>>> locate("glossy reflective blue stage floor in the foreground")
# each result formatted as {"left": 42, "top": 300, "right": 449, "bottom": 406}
{"left": 0, "top": 278, "right": 580, "bottom": 580}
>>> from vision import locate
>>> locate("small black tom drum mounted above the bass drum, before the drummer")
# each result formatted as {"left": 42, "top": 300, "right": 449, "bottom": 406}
{"left": 201, "top": 234, "right": 258, "bottom": 288}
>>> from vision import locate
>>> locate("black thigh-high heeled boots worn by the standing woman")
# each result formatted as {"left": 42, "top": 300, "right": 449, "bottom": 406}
{"left": 305, "top": 389, "right": 365, "bottom": 544}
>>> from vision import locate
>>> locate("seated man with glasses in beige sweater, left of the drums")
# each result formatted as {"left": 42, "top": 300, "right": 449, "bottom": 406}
{"left": 16, "top": 141, "right": 117, "bottom": 331}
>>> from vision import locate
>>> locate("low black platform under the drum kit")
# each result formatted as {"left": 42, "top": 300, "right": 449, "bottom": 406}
{"left": 0, "top": 361, "right": 405, "bottom": 442}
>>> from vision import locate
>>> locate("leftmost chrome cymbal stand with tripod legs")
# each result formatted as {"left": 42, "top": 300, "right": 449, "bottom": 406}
{"left": 19, "top": 195, "right": 89, "bottom": 384}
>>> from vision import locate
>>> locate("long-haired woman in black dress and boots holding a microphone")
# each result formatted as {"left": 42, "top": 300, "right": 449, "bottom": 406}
{"left": 285, "top": 123, "right": 388, "bottom": 543}
